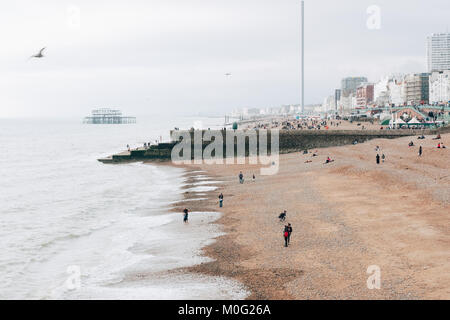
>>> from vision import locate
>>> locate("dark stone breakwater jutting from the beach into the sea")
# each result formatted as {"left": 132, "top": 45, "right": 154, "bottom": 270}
{"left": 98, "top": 126, "right": 444, "bottom": 163}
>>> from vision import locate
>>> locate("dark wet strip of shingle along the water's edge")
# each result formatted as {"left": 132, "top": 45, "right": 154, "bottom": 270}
{"left": 158, "top": 162, "right": 302, "bottom": 300}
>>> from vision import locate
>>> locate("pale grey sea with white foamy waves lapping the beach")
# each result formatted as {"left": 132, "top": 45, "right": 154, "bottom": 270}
{"left": 0, "top": 116, "right": 248, "bottom": 300}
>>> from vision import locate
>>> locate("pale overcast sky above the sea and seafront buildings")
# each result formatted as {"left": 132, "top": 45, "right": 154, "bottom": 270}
{"left": 0, "top": 0, "right": 450, "bottom": 117}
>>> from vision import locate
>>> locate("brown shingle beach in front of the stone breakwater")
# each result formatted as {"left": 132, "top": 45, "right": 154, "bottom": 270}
{"left": 163, "top": 134, "right": 450, "bottom": 299}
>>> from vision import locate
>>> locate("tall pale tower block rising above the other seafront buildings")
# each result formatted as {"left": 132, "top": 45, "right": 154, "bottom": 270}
{"left": 427, "top": 33, "right": 450, "bottom": 72}
